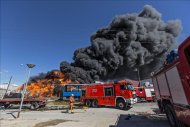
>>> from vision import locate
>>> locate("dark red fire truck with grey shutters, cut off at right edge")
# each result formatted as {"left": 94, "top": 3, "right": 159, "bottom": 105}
{"left": 152, "top": 37, "right": 190, "bottom": 127}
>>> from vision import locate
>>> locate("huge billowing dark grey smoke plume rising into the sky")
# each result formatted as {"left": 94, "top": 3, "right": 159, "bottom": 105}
{"left": 60, "top": 5, "right": 182, "bottom": 83}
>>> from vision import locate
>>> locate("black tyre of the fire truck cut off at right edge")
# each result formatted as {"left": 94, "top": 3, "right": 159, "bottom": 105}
{"left": 165, "top": 104, "right": 178, "bottom": 127}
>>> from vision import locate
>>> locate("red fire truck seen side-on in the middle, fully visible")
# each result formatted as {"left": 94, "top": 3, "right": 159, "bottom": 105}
{"left": 81, "top": 80, "right": 136, "bottom": 109}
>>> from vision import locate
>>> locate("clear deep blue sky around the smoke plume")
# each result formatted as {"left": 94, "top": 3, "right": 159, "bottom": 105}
{"left": 0, "top": 0, "right": 190, "bottom": 85}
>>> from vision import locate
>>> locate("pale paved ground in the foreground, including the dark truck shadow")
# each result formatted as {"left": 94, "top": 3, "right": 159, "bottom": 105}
{"left": 0, "top": 103, "right": 169, "bottom": 127}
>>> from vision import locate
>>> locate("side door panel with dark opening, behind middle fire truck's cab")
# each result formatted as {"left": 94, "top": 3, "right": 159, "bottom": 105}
{"left": 104, "top": 87, "right": 115, "bottom": 106}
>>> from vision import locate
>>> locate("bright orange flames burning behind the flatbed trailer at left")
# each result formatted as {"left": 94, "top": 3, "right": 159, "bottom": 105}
{"left": 17, "top": 71, "right": 72, "bottom": 97}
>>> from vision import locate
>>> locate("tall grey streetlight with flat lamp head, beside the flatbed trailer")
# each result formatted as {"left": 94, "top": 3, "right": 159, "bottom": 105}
{"left": 17, "top": 64, "right": 35, "bottom": 118}
